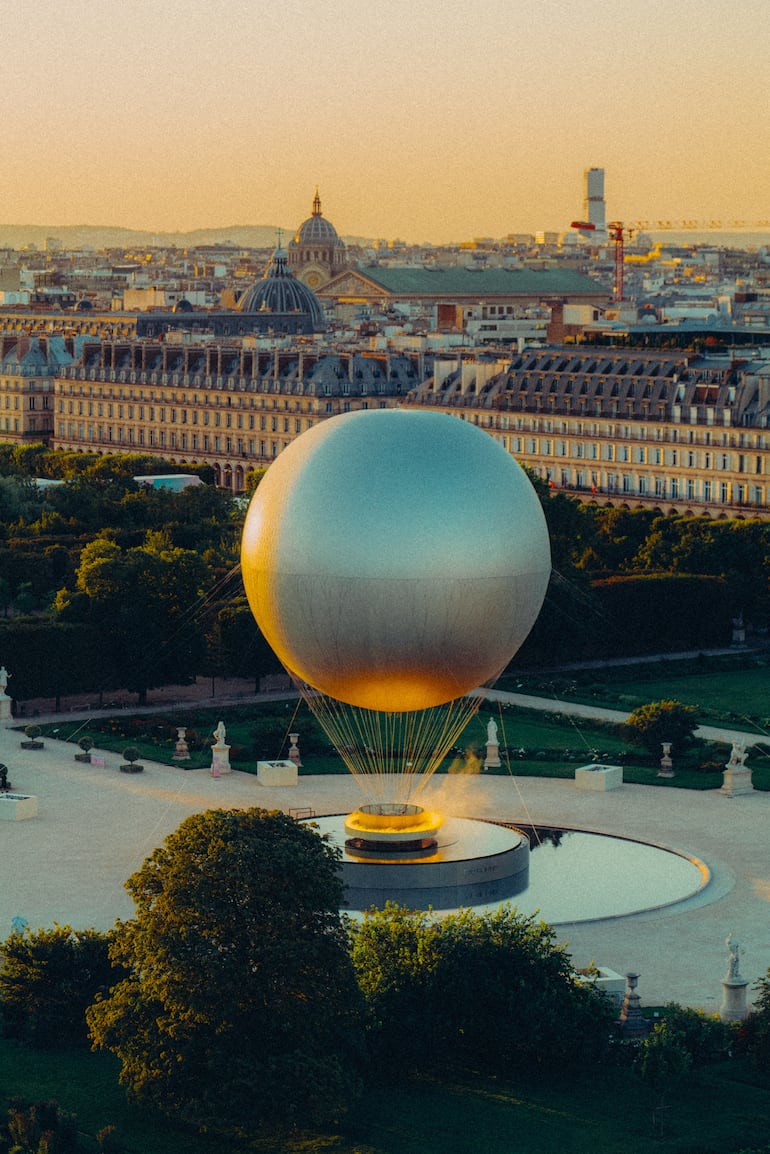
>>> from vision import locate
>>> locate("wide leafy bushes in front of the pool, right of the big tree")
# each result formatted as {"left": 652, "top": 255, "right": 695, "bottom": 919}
{"left": 352, "top": 905, "right": 614, "bottom": 1077}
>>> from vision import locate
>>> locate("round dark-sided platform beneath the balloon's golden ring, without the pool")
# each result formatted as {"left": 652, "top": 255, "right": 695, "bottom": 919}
{"left": 313, "top": 816, "right": 530, "bottom": 911}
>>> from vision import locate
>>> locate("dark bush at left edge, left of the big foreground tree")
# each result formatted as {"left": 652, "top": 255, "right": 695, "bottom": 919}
{"left": 0, "top": 926, "right": 122, "bottom": 1049}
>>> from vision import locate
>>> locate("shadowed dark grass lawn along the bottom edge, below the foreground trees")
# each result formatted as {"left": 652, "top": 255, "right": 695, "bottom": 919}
{"left": 0, "top": 1041, "right": 770, "bottom": 1154}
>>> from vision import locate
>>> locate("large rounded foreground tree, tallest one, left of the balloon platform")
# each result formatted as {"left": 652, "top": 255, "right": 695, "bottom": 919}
{"left": 89, "top": 809, "right": 361, "bottom": 1132}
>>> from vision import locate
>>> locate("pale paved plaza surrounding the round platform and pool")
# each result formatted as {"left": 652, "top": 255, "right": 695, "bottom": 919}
{"left": 0, "top": 724, "right": 770, "bottom": 1012}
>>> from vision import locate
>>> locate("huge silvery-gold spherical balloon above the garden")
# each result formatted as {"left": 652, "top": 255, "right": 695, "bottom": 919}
{"left": 241, "top": 409, "right": 551, "bottom": 712}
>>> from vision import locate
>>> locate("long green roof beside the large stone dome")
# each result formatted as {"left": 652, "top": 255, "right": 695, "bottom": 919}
{"left": 359, "top": 265, "right": 610, "bottom": 300}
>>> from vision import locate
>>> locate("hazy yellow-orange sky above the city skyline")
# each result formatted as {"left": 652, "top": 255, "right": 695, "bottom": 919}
{"left": 0, "top": 0, "right": 770, "bottom": 243}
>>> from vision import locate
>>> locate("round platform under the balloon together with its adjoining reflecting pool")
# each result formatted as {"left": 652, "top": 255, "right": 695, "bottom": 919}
{"left": 312, "top": 816, "right": 710, "bottom": 926}
